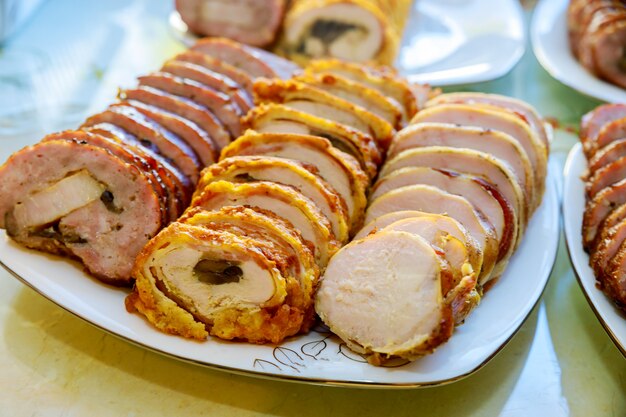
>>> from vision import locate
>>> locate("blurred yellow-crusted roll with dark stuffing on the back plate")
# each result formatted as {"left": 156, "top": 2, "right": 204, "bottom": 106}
{"left": 278, "top": 0, "right": 412, "bottom": 64}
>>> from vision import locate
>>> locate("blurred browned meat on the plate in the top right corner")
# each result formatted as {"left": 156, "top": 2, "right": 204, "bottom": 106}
{"left": 567, "top": 0, "right": 626, "bottom": 88}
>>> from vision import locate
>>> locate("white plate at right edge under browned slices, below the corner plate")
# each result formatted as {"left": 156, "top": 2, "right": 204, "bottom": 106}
{"left": 563, "top": 144, "right": 626, "bottom": 356}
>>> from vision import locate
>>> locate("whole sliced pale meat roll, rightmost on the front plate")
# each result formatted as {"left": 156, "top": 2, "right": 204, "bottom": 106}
{"left": 316, "top": 93, "right": 551, "bottom": 364}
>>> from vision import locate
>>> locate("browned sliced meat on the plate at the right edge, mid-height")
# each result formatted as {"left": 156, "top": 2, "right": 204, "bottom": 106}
{"left": 580, "top": 104, "right": 626, "bottom": 310}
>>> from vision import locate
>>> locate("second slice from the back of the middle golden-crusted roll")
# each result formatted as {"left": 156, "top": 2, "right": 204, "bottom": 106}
{"left": 295, "top": 73, "right": 403, "bottom": 129}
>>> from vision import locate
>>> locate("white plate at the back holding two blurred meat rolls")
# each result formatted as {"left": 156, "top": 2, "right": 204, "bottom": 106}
{"left": 170, "top": 0, "right": 526, "bottom": 86}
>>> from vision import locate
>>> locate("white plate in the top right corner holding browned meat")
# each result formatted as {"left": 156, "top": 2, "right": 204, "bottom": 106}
{"left": 531, "top": 0, "right": 626, "bottom": 103}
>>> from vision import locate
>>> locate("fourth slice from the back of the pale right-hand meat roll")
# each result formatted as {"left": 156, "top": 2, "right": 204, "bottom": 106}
{"left": 381, "top": 146, "right": 526, "bottom": 239}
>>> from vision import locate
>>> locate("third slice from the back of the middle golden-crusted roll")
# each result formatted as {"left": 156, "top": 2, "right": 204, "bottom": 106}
{"left": 254, "top": 80, "right": 395, "bottom": 151}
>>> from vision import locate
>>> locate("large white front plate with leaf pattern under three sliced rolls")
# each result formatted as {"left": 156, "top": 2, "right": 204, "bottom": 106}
{"left": 0, "top": 164, "right": 559, "bottom": 386}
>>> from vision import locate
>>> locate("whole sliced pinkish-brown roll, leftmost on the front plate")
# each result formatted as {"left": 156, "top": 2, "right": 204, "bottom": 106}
{"left": 0, "top": 39, "right": 297, "bottom": 285}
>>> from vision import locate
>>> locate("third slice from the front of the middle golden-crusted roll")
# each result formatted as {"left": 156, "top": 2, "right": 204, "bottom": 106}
{"left": 192, "top": 181, "right": 339, "bottom": 266}
